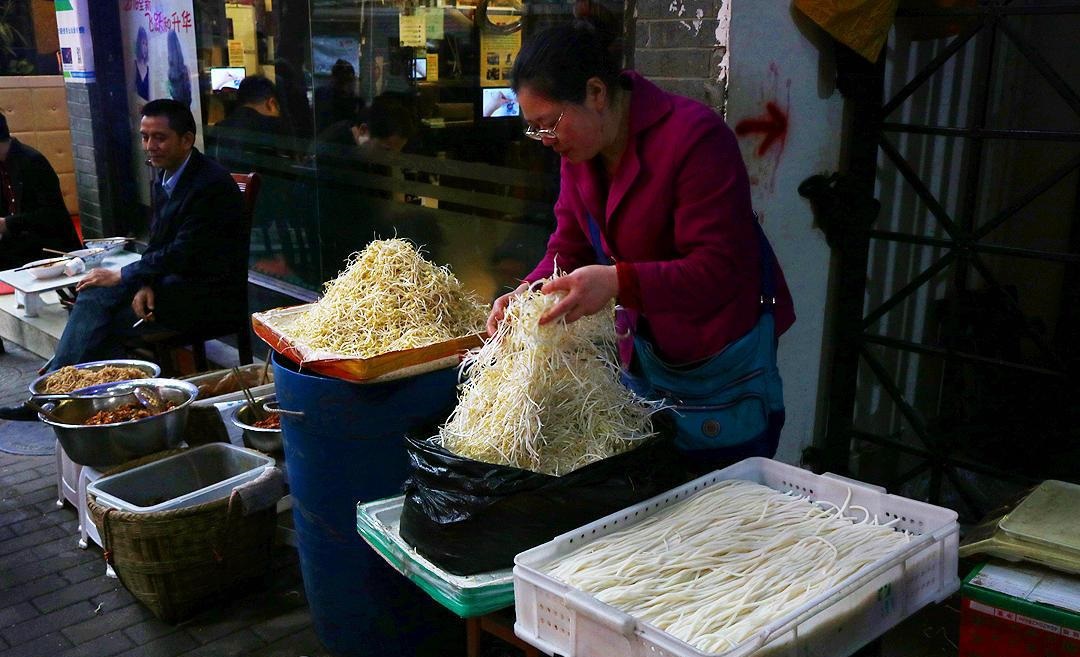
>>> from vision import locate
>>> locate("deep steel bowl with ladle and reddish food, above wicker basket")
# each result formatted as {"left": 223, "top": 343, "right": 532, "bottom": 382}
{"left": 38, "top": 378, "right": 199, "bottom": 468}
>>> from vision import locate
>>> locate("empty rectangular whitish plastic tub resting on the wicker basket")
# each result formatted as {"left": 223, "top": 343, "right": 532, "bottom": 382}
{"left": 86, "top": 443, "right": 274, "bottom": 513}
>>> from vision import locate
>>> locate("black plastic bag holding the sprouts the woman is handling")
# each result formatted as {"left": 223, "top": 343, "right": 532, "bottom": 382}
{"left": 401, "top": 417, "right": 687, "bottom": 575}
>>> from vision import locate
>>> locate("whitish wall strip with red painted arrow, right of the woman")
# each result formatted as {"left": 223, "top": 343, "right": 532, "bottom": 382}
{"left": 727, "top": 0, "right": 843, "bottom": 462}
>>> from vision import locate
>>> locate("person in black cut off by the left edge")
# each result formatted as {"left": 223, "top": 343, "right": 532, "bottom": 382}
{"left": 0, "top": 113, "right": 81, "bottom": 269}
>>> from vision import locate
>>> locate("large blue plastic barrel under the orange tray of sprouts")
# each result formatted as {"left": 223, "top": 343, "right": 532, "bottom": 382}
{"left": 273, "top": 354, "right": 464, "bottom": 657}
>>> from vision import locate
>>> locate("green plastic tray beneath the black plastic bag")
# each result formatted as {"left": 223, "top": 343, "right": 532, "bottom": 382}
{"left": 356, "top": 496, "right": 514, "bottom": 618}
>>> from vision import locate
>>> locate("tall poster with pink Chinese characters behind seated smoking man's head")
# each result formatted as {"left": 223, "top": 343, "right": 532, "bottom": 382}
{"left": 119, "top": 0, "right": 203, "bottom": 204}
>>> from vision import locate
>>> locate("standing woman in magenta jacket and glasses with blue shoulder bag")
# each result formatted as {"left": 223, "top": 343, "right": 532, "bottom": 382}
{"left": 488, "top": 22, "right": 795, "bottom": 470}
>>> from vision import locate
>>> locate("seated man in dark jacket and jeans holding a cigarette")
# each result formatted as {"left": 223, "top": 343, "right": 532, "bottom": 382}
{"left": 0, "top": 98, "right": 249, "bottom": 419}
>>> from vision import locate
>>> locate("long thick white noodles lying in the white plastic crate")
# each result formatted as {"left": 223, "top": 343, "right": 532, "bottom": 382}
{"left": 546, "top": 480, "right": 910, "bottom": 653}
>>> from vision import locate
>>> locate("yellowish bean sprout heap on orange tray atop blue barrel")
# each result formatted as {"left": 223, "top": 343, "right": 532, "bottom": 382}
{"left": 282, "top": 239, "right": 487, "bottom": 358}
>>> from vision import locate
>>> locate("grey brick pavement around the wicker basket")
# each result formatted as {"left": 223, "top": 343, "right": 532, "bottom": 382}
{"left": 0, "top": 341, "right": 328, "bottom": 657}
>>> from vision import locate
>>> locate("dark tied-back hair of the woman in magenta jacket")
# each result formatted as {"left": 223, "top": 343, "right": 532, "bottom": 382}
{"left": 510, "top": 19, "right": 622, "bottom": 104}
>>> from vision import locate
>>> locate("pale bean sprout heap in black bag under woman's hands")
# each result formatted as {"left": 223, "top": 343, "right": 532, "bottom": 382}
{"left": 438, "top": 278, "right": 654, "bottom": 477}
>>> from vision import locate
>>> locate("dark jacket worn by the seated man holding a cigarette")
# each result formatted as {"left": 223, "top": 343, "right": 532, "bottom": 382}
{"left": 121, "top": 149, "right": 251, "bottom": 331}
